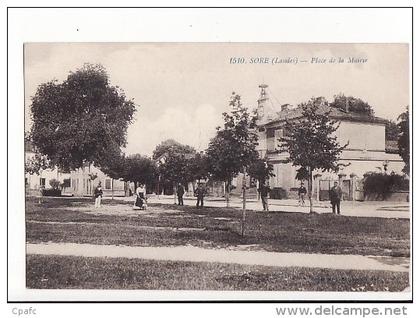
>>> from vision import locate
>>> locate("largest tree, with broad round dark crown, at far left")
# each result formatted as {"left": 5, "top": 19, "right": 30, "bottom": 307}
{"left": 30, "top": 64, "right": 135, "bottom": 169}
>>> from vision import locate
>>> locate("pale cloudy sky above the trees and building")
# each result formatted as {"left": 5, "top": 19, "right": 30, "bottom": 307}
{"left": 24, "top": 43, "right": 410, "bottom": 155}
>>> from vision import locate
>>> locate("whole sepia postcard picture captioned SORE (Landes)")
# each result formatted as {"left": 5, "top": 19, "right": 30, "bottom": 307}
{"left": 22, "top": 42, "right": 412, "bottom": 300}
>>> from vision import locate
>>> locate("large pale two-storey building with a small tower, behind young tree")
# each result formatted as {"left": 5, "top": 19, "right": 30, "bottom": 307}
{"left": 257, "top": 85, "right": 404, "bottom": 200}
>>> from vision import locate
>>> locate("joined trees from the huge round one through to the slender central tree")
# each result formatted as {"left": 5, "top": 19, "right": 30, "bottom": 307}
{"left": 26, "top": 64, "right": 276, "bottom": 207}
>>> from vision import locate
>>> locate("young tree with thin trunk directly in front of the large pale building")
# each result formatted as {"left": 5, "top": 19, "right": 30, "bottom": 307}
{"left": 280, "top": 98, "right": 348, "bottom": 212}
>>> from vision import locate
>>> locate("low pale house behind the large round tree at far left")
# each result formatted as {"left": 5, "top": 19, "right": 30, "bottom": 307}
{"left": 25, "top": 142, "right": 126, "bottom": 196}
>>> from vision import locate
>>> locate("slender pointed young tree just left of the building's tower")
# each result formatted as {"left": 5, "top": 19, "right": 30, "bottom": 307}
{"left": 206, "top": 92, "right": 258, "bottom": 206}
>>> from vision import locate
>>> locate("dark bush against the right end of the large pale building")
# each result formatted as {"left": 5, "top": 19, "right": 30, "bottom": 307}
{"left": 363, "top": 172, "right": 409, "bottom": 200}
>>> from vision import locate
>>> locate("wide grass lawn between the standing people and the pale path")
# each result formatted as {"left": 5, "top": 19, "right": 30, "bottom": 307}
{"left": 26, "top": 198, "right": 410, "bottom": 256}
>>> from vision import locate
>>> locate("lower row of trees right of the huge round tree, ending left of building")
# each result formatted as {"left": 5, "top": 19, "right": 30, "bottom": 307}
{"left": 102, "top": 93, "right": 273, "bottom": 206}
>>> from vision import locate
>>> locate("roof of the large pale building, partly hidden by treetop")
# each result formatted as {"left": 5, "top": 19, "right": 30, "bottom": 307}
{"left": 263, "top": 104, "right": 386, "bottom": 125}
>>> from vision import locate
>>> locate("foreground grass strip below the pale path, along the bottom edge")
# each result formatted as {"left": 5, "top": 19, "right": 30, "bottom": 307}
{"left": 26, "top": 255, "right": 409, "bottom": 291}
